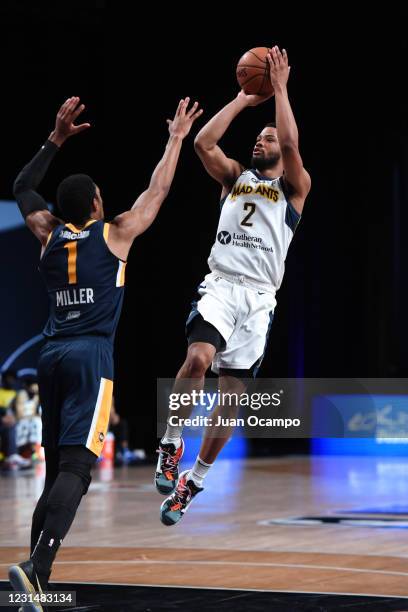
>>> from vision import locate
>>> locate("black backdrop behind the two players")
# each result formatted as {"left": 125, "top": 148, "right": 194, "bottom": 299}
{"left": 0, "top": 2, "right": 408, "bottom": 452}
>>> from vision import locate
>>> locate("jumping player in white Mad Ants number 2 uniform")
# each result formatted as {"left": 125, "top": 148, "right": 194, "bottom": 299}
{"left": 155, "top": 47, "right": 310, "bottom": 525}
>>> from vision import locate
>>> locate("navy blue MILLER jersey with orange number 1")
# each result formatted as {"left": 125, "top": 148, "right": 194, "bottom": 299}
{"left": 39, "top": 220, "right": 126, "bottom": 340}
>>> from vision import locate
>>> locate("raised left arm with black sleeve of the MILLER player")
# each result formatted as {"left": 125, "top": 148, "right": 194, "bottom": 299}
{"left": 13, "top": 97, "right": 89, "bottom": 246}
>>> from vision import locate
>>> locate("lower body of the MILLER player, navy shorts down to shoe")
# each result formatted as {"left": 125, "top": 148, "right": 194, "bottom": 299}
{"left": 9, "top": 337, "right": 113, "bottom": 610}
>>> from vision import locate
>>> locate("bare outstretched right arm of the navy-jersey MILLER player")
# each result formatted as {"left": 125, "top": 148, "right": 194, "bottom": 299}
{"left": 108, "top": 98, "right": 203, "bottom": 259}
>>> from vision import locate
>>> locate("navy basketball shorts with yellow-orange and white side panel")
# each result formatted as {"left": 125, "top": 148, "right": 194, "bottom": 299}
{"left": 38, "top": 336, "right": 113, "bottom": 457}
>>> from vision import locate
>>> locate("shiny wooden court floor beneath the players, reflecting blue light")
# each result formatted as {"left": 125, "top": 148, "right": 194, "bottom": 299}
{"left": 0, "top": 457, "right": 408, "bottom": 597}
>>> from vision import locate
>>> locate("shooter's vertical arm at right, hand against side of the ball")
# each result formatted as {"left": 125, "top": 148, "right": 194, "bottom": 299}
{"left": 267, "top": 46, "right": 311, "bottom": 214}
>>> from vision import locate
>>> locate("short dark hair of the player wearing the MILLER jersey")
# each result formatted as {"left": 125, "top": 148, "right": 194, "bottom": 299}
{"left": 57, "top": 174, "right": 96, "bottom": 225}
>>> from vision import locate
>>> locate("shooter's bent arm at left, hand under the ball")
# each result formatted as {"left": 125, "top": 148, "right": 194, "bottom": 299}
{"left": 194, "top": 91, "right": 271, "bottom": 191}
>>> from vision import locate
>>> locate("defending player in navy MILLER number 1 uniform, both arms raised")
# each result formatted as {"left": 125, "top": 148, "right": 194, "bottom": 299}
{"left": 9, "top": 97, "right": 202, "bottom": 610}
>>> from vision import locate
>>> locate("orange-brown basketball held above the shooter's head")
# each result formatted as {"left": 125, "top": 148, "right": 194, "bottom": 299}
{"left": 237, "top": 47, "right": 273, "bottom": 96}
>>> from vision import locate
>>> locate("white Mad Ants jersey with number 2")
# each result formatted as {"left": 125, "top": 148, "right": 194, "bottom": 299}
{"left": 208, "top": 170, "right": 300, "bottom": 290}
